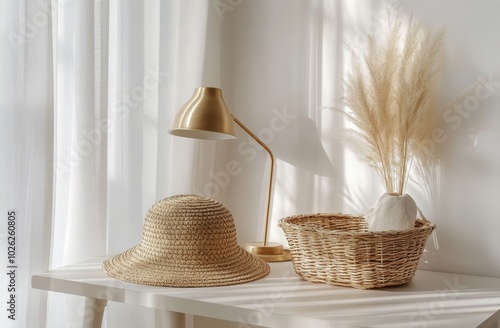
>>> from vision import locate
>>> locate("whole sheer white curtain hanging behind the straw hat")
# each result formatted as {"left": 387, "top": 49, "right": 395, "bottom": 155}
{"left": 0, "top": 0, "right": 219, "bottom": 328}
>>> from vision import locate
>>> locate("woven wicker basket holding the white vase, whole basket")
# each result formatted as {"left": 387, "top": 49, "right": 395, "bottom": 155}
{"left": 279, "top": 214, "right": 436, "bottom": 289}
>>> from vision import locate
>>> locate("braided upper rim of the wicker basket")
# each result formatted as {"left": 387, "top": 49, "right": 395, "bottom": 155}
{"left": 278, "top": 213, "right": 436, "bottom": 237}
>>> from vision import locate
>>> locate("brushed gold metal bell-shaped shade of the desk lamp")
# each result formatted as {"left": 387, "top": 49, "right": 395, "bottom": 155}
{"left": 169, "top": 87, "right": 236, "bottom": 140}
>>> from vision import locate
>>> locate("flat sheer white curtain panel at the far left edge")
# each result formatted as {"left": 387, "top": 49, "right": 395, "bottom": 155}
{"left": 0, "top": 1, "right": 54, "bottom": 327}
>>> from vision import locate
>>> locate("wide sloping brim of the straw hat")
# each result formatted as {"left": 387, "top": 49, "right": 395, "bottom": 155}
{"left": 103, "top": 245, "right": 270, "bottom": 287}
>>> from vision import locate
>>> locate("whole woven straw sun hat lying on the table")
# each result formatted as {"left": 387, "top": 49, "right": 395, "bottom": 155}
{"left": 103, "top": 195, "right": 269, "bottom": 287}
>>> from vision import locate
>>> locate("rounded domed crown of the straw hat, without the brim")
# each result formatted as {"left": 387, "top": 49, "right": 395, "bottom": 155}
{"left": 139, "top": 195, "right": 238, "bottom": 263}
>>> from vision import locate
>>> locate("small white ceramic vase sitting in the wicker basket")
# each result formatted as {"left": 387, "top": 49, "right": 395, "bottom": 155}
{"left": 365, "top": 193, "right": 417, "bottom": 231}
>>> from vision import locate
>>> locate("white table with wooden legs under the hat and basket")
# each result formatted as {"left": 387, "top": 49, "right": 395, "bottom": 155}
{"left": 32, "top": 258, "right": 500, "bottom": 328}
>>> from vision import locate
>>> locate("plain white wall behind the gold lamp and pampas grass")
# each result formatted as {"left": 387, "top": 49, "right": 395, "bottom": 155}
{"left": 207, "top": 0, "right": 500, "bottom": 276}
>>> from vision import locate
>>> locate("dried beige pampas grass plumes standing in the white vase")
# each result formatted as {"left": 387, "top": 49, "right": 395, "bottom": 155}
{"left": 343, "top": 17, "right": 444, "bottom": 195}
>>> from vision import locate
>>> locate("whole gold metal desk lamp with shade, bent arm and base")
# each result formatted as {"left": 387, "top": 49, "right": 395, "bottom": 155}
{"left": 169, "top": 87, "right": 291, "bottom": 262}
